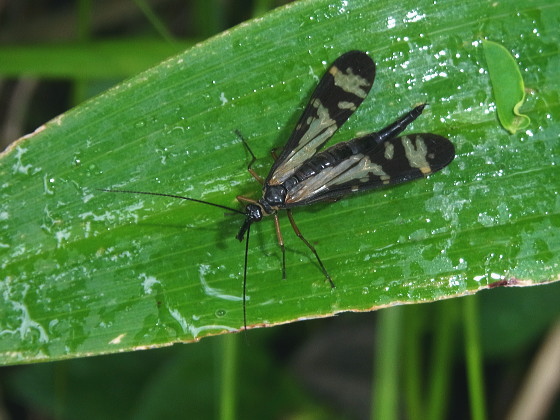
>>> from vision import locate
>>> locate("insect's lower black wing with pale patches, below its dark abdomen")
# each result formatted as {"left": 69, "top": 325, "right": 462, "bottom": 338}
{"left": 286, "top": 133, "right": 455, "bottom": 207}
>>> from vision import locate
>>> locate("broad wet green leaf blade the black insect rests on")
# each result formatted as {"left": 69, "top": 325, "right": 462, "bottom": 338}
{"left": 0, "top": 0, "right": 560, "bottom": 364}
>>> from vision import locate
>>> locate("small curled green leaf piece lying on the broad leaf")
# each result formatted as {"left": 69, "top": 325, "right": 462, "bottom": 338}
{"left": 482, "top": 40, "right": 531, "bottom": 134}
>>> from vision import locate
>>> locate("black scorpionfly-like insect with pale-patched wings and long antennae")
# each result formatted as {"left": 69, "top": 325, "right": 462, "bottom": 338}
{"left": 103, "top": 51, "right": 455, "bottom": 329}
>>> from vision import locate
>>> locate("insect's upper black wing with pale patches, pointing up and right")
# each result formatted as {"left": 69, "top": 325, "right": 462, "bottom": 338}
{"left": 266, "top": 51, "right": 375, "bottom": 185}
